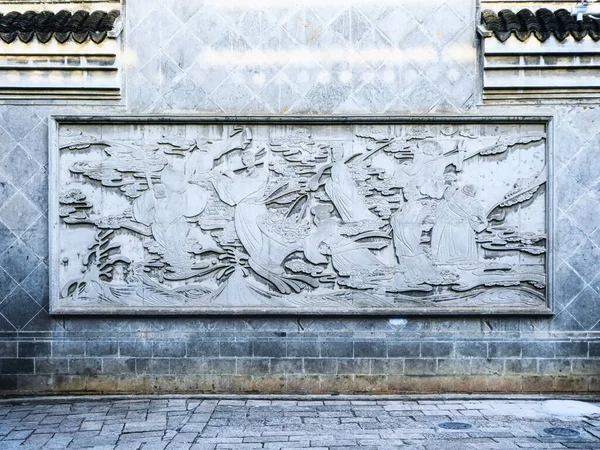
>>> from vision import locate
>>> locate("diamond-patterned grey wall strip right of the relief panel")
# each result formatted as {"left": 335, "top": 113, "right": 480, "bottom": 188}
{"left": 554, "top": 108, "right": 600, "bottom": 330}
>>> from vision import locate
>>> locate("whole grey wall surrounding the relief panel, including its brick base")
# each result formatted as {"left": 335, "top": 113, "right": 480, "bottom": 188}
{"left": 0, "top": 0, "right": 600, "bottom": 393}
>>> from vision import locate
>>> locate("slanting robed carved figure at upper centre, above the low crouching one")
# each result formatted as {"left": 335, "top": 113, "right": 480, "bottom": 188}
{"left": 325, "top": 145, "right": 379, "bottom": 222}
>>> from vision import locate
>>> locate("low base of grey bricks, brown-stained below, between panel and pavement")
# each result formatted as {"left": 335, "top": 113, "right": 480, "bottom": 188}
{"left": 0, "top": 326, "right": 600, "bottom": 395}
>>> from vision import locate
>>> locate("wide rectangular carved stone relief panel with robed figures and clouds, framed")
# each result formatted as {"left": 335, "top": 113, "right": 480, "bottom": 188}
{"left": 50, "top": 117, "right": 550, "bottom": 314}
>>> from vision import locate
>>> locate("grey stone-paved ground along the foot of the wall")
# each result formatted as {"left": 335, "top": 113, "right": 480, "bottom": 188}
{"left": 0, "top": 397, "right": 600, "bottom": 450}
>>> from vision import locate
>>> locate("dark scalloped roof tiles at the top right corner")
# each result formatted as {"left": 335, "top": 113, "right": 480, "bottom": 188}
{"left": 481, "top": 8, "right": 600, "bottom": 42}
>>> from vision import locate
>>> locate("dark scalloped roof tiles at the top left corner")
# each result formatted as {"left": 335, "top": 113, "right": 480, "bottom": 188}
{"left": 0, "top": 10, "right": 119, "bottom": 43}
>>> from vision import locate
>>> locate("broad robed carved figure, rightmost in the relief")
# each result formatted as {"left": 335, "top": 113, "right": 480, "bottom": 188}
{"left": 431, "top": 184, "right": 488, "bottom": 265}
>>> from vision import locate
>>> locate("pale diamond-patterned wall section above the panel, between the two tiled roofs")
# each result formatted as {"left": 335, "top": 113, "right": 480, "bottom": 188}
{"left": 125, "top": 0, "right": 476, "bottom": 114}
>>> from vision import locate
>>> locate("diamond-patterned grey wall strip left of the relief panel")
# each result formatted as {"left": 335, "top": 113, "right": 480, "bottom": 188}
{"left": 0, "top": 106, "right": 48, "bottom": 331}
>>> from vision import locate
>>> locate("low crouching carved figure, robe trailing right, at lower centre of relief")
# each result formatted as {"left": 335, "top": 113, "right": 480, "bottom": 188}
{"left": 303, "top": 205, "right": 386, "bottom": 281}
